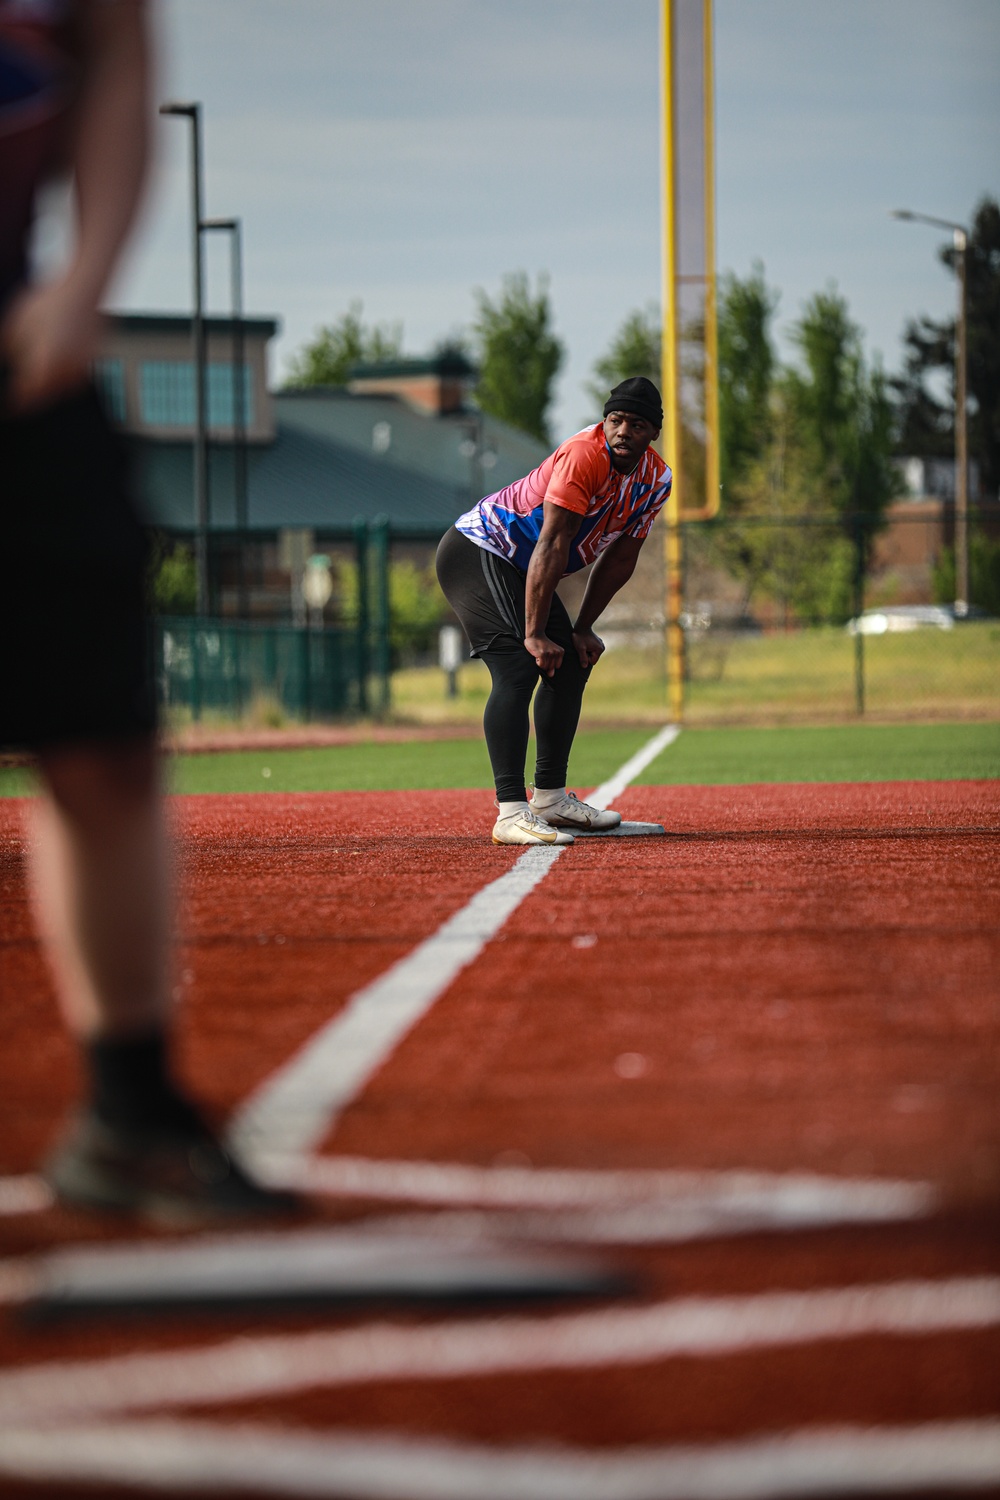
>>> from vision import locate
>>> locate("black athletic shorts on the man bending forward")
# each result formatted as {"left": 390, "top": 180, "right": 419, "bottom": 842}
{"left": 436, "top": 527, "right": 573, "bottom": 656}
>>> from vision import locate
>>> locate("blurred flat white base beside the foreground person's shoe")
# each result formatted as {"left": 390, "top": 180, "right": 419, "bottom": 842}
{"left": 11, "top": 1229, "right": 627, "bottom": 1317}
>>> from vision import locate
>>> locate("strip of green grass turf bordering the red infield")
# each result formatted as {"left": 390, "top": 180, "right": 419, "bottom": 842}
{"left": 0, "top": 723, "right": 1000, "bottom": 797}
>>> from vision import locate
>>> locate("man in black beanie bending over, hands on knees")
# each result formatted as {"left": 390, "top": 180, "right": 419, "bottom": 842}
{"left": 438, "top": 375, "right": 670, "bottom": 845}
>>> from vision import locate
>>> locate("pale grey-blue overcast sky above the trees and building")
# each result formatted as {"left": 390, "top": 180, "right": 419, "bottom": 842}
{"left": 105, "top": 0, "right": 1000, "bottom": 437}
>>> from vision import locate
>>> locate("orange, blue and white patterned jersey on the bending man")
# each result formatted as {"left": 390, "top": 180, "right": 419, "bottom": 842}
{"left": 456, "top": 422, "right": 670, "bottom": 573}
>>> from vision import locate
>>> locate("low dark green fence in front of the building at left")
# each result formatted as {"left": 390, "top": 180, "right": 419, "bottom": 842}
{"left": 153, "top": 618, "right": 369, "bottom": 720}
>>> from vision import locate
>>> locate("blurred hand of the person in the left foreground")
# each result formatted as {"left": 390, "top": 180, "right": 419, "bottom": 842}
{"left": 0, "top": 279, "right": 100, "bottom": 413}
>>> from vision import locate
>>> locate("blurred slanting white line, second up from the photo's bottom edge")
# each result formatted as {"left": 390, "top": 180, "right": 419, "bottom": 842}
{"left": 0, "top": 1277, "right": 1000, "bottom": 1428}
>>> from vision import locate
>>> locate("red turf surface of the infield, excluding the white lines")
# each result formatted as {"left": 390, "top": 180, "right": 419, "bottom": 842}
{"left": 0, "top": 783, "right": 1000, "bottom": 1496}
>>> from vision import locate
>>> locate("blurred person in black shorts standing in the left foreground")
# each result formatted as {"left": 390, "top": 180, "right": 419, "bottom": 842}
{"left": 0, "top": 0, "right": 292, "bottom": 1223}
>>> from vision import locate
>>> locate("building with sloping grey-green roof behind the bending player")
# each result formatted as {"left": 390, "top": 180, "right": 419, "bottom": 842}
{"left": 97, "top": 314, "right": 547, "bottom": 617}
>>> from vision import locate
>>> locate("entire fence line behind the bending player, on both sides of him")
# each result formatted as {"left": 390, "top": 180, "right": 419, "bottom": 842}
{"left": 154, "top": 501, "right": 1000, "bottom": 725}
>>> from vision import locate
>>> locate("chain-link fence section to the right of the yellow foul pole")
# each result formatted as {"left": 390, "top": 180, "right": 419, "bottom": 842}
{"left": 682, "top": 506, "right": 1000, "bottom": 723}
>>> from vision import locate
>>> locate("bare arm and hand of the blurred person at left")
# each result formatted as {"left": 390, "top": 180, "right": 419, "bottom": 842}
{"left": 0, "top": 0, "right": 150, "bottom": 410}
